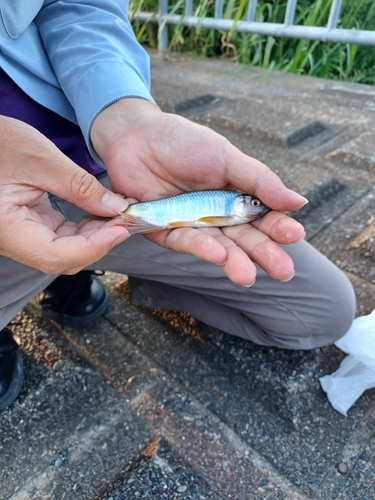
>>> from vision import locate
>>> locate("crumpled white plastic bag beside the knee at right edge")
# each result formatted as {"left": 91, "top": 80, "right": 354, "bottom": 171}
{"left": 319, "top": 309, "right": 375, "bottom": 415}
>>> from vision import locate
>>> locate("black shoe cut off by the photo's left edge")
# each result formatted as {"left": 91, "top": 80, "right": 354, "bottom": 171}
{"left": 0, "top": 328, "right": 23, "bottom": 411}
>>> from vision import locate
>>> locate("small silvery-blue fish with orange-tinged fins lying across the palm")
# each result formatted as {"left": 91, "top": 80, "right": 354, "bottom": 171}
{"left": 110, "top": 189, "right": 271, "bottom": 234}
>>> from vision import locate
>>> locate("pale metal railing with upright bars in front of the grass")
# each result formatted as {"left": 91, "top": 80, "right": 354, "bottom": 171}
{"left": 133, "top": 0, "right": 375, "bottom": 52}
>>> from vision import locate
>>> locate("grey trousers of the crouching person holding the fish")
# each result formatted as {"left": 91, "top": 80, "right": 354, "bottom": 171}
{"left": 0, "top": 174, "right": 355, "bottom": 349}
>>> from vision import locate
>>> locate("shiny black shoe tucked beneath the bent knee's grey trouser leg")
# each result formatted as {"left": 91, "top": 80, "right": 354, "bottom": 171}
{"left": 37, "top": 271, "right": 108, "bottom": 326}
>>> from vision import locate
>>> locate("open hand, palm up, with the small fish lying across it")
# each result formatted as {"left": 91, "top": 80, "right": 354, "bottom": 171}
{"left": 91, "top": 99, "right": 306, "bottom": 286}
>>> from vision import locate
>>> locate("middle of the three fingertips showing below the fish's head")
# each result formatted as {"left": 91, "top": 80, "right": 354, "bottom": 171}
{"left": 223, "top": 224, "right": 294, "bottom": 281}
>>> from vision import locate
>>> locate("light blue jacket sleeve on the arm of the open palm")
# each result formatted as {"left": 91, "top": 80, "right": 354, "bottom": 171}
{"left": 35, "top": 0, "right": 153, "bottom": 164}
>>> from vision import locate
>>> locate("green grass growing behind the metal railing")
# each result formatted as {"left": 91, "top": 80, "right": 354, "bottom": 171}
{"left": 130, "top": 0, "right": 375, "bottom": 85}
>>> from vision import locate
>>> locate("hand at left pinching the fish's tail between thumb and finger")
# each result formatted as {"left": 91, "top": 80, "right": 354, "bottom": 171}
{"left": 0, "top": 116, "right": 129, "bottom": 274}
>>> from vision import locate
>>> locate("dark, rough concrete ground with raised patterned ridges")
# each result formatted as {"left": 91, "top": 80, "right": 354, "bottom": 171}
{"left": 0, "top": 47, "right": 375, "bottom": 500}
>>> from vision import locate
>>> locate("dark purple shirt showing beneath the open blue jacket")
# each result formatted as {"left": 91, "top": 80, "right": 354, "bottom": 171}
{"left": 0, "top": 68, "right": 103, "bottom": 175}
